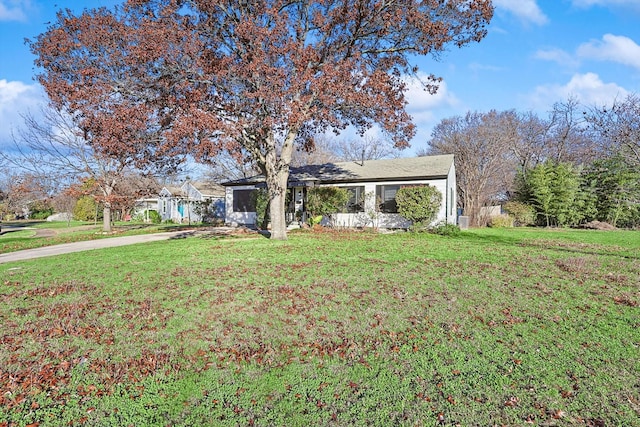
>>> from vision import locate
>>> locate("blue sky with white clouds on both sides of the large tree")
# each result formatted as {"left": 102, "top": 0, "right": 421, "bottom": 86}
{"left": 0, "top": 0, "right": 640, "bottom": 155}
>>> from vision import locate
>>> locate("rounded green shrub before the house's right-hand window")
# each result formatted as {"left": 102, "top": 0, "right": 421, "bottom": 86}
{"left": 396, "top": 185, "right": 442, "bottom": 230}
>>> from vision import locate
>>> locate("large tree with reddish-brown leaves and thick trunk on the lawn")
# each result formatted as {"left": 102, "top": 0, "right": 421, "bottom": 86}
{"left": 32, "top": 0, "right": 493, "bottom": 239}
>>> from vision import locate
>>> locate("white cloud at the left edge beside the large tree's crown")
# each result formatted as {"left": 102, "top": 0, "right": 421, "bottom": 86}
{"left": 0, "top": 79, "right": 44, "bottom": 147}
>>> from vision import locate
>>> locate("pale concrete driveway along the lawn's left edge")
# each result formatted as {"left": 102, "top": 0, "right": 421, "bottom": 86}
{"left": 0, "top": 231, "right": 200, "bottom": 264}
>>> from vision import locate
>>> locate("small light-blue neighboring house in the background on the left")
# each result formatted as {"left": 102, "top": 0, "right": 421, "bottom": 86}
{"left": 156, "top": 181, "right": 225, "bottom": 224}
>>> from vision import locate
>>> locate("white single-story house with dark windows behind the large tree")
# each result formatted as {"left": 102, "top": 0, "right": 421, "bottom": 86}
{"left": 222, "top": 155, "right": 457, "bottom": 228}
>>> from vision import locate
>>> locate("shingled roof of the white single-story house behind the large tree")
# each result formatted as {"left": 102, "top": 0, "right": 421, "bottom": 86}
{"left": 222, "top": 154, "right": 453, "bottom": 186}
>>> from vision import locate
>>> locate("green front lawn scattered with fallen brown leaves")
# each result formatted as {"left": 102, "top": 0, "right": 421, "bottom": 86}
{"left": 0, "top": 229, "right": 640, "bottom": 427}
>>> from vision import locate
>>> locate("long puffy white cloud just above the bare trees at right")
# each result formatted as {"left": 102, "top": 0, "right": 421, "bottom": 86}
{"left": 528, "top": 73, "right": 629, "bottom": 110}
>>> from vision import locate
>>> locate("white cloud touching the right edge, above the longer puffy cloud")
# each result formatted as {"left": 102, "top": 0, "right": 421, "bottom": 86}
{"left": 577, "top": 34, "right": 640, "bottom": 70}
